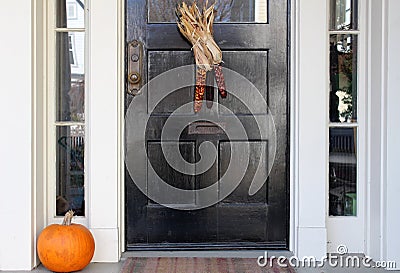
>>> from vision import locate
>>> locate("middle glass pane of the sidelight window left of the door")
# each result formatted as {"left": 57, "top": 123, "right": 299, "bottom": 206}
{"left": 56, "top": 32, "right": 85, "bottom": 121}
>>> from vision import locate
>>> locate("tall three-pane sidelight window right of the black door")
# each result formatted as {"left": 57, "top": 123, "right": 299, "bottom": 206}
{"left": 329, "top": 0, "right": 360, "bottom": 216}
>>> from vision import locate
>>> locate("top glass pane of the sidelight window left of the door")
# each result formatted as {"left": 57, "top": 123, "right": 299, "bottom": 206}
{"left": 56, "top": 0, "right": 85, "bottom": 28}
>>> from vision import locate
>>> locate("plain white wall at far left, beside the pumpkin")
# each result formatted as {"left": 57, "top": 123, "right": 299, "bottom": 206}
{"left": 0, "top": 0, "right": 34, "bottom": 270}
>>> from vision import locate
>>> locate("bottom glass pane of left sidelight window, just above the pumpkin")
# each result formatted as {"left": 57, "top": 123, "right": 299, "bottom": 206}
{"left": 56, "top": 125, "right": 85, "bottom": 216}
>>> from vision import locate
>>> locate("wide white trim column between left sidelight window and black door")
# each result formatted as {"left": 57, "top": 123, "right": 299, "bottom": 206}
{"left": 87, "top": 1, "right": 124, "bottom": 262}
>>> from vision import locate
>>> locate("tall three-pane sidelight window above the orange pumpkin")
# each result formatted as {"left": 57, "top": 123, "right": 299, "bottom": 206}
{"left": 48, "top": 0, "right": 86, "bottom": 216}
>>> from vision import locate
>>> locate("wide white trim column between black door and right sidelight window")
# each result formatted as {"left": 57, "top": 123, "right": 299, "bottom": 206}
{"left": 291, "top": 0, "right": 328, "bottom": 258}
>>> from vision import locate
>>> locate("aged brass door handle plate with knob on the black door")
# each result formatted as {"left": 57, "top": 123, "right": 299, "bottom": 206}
{"left": 126, "top": 40, "right": 143, "bottom": 96}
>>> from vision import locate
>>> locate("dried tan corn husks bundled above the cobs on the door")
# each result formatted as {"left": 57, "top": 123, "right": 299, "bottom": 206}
{"left": 176, "top": 2, "right": 222, "bottom": 71}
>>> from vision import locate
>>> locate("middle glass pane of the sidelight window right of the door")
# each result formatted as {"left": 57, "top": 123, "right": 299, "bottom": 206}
{"left": 329, "top": 34, "right": 357, "bottom": 122}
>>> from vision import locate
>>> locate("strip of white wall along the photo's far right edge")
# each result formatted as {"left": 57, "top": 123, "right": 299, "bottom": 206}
{"left": 385, "top": 0, "right": 400, "bottom": 268}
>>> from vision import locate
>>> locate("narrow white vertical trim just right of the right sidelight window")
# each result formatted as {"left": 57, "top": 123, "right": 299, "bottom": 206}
{"left": 366, "top": 0, "right": 387, "bottom": 260}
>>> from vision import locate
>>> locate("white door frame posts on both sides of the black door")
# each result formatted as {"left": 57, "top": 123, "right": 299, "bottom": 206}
{"left": 32, "top": 0, "right": 328, "bottom": 262}
